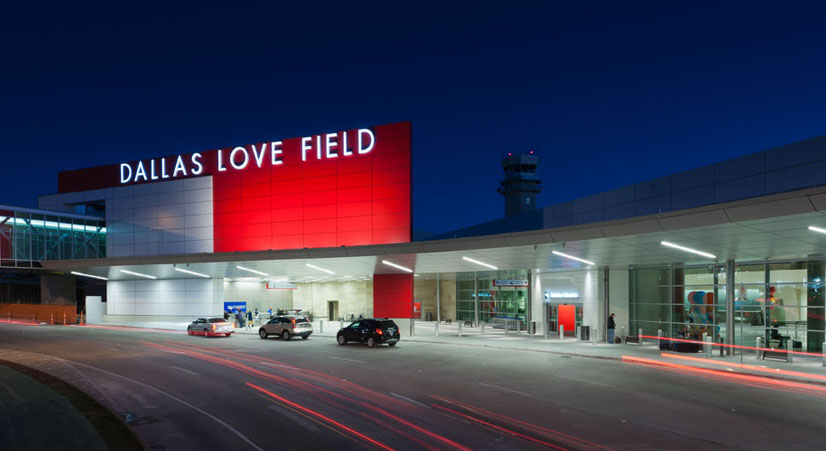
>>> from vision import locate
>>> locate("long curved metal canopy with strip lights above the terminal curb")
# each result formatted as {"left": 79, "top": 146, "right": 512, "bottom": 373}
{"left": 42, "top": 187, "right": 826, "bottom": 281}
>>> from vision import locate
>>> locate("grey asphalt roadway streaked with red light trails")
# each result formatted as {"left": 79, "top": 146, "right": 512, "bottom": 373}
{"left": 0, "top": 323, "right": 826, "bottom": 450}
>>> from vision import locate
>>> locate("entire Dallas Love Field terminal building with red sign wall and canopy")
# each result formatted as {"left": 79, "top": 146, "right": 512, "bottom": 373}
{"left": 0, "top": 122, "right": 826, "bottom": 352}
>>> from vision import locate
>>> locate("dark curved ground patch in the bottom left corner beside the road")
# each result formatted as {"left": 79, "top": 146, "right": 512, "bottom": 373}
{"left": 0, "top": 362, "right": 107, "bottom": 451}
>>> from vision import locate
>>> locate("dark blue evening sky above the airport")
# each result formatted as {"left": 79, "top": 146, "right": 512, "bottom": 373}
{"left": 0, "top": 2, "right": 826, "bottom": 232}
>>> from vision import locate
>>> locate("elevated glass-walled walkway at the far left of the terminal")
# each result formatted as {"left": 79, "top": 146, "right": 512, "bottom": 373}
{"left": 0, "top": 209, "right": 106, "bottom": 268}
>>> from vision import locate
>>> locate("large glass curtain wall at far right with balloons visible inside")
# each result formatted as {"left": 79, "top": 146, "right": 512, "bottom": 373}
{"left": 629, "top": 259, "right": 826, "bottom": 352}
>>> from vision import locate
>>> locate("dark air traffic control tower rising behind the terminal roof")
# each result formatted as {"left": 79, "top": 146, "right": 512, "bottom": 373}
{"left": 497, "top": 150, "right": 542, "bottom": 217}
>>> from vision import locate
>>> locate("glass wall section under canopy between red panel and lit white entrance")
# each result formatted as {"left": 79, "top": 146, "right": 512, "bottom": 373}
{"left": 456, "top": 270, "right": 530, "bottom": 328}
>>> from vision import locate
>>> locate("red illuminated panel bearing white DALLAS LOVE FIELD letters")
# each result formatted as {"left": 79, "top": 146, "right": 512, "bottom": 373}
{"left": 58, "top": 122, "right": 411, "bottom": 252}
